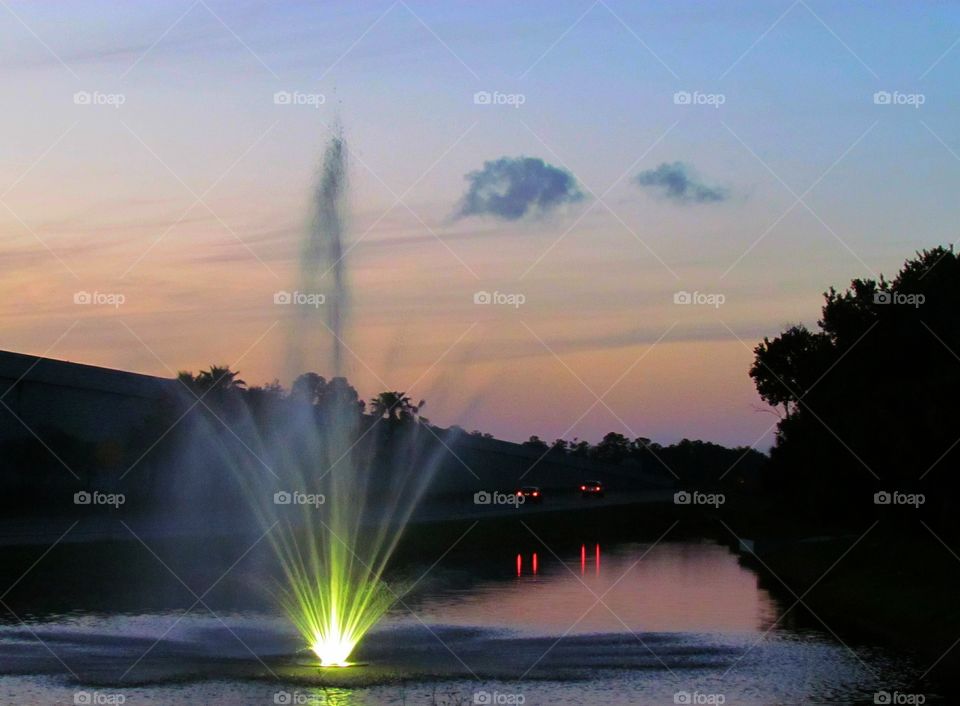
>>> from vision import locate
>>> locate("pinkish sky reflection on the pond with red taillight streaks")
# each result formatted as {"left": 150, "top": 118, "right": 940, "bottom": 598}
{"left": 431, "top": 539, "right": 778, "bottom": 634}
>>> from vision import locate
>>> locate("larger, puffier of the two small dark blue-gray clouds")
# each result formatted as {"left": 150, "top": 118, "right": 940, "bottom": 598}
{"left": 454, "top": 157, "right": 583, "bottom": 221}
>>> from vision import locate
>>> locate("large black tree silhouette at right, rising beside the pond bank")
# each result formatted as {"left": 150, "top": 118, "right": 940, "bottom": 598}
{"left": 750, "top": 247, "right": 960, "bottom": 521}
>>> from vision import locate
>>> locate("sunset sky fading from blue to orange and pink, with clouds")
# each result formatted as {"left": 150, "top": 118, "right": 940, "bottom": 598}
{"left": 0, "top": 0, "right": 960, "bottom": 450}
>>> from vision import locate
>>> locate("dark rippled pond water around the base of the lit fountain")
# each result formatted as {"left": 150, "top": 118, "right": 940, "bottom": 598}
{"left": 0, "top": 536, "right": 936, "bottom": 705}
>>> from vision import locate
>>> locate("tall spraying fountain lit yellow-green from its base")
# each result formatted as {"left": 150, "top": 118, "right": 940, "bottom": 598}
{"left": 189, "top": 125, "right": 448, "bottom": 667}
